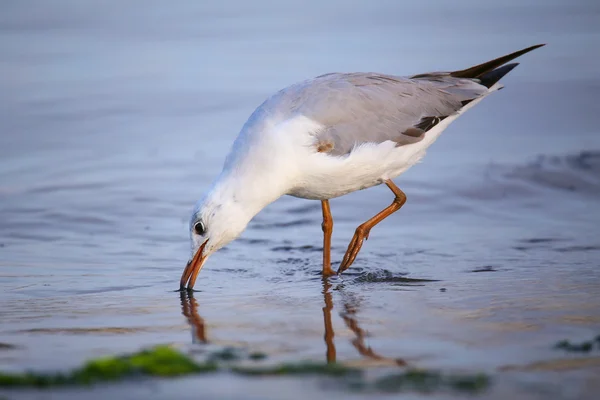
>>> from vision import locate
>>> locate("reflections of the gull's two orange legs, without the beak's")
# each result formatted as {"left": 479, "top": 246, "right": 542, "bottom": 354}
{"left": 323, "top": 279, "right": 406, "bottom": 366}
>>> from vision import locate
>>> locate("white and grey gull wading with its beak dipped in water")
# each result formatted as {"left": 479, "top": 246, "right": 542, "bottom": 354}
{"left": 180, "top": 44, "right": 544, "bottom": 290}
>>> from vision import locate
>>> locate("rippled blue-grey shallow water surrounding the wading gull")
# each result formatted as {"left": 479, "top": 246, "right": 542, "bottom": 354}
{"left": 0, "top": 0, "right": 600, "bottom": 398}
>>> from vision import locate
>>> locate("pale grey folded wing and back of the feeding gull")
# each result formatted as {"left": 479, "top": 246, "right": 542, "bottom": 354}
{"left": 248, "top": 73, "right": 488, "bottom": 155}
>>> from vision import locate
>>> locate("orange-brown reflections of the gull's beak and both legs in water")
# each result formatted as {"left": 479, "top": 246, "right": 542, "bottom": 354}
{"left": 180, "top": 279, "right": 406, "bottom": 366}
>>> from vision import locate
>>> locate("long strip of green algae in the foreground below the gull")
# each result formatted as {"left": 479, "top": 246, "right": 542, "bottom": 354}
{"left": 0, "top": 346, "right": 490, "bottom": 393}
